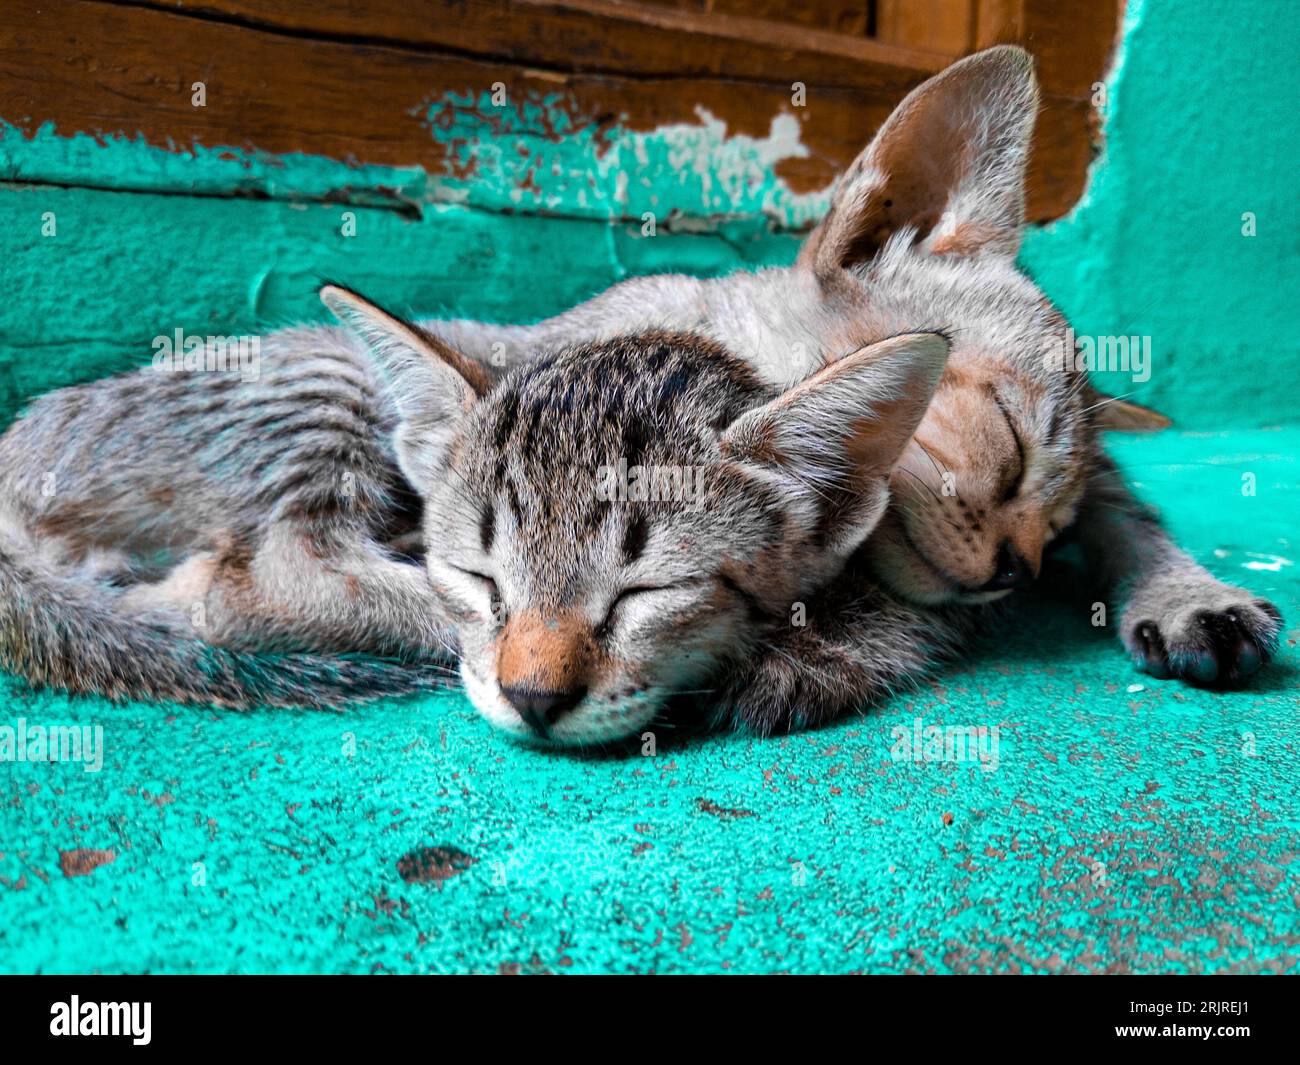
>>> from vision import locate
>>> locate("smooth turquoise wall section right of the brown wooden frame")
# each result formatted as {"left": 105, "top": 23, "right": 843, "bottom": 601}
{"left": 1022, "top": 0, "right": 1300, "bottom": 429}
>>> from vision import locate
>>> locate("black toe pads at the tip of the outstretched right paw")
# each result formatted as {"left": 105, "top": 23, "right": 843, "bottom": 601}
{"left": 1126, "top": 595, "right": 1282, "bottom": 685}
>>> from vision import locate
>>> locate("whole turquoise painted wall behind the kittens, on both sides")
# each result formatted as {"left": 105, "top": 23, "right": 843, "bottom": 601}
{"left": 0, "top": 0, "right": 1300, "bottom": 428}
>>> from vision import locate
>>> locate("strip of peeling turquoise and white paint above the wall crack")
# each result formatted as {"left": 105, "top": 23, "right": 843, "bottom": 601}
{"left": 0, "top": 92, "right": 829, "bottom": 231}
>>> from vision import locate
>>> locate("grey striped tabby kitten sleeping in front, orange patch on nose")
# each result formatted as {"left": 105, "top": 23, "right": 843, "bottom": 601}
{"left": 0, "top": 286, "right": 948, "bottom": 744}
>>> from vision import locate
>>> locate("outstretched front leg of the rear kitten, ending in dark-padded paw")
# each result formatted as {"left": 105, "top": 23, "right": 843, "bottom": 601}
{"left": 1076, "top": 458, "right": 1282, "bottom": 684}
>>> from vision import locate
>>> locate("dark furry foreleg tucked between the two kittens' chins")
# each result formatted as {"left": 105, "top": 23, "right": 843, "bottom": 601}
{"left": 716, "top": 573, "right": 978, "bottom": 735}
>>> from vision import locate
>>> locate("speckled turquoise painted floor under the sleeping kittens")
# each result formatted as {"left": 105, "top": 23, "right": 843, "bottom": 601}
{"left": 0, "top": 430, "right": 1300, "bottom": 973}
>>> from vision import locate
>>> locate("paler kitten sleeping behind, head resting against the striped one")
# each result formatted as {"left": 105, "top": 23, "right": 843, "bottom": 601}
{"left": 424, "top": 47, "right": 1281, "bottom": 722}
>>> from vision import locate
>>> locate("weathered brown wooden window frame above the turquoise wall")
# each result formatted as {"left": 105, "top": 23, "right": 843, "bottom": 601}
{"left": 0, "top": 0, "right": 1117, "bottom": 220}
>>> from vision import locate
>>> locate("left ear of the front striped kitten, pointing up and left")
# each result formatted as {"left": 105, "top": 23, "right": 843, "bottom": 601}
{"left": 320, "top": 285, "right": 488, "bottom": 495}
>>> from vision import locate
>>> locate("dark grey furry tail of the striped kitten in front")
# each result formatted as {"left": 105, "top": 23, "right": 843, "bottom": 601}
{"left": 0, "top": 538, "right": 452, "bottom": 709}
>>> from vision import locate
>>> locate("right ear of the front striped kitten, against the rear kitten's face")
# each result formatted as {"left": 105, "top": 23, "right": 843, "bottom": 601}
{"left": 722, "top": 333, "right": 948, "bottom": 557}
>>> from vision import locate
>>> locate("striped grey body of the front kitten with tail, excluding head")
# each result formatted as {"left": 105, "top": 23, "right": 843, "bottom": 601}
{"left": 0, "top": 322, "right": 454, "bottom": 706}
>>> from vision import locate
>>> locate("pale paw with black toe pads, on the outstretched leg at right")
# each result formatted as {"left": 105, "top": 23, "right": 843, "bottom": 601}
{"left": 1122, "top": 577, "right": 1282, "bottom": 685}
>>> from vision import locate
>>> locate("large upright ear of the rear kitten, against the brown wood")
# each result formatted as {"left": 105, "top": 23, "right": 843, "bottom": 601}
{"left": 800, "top": 44, "right": 1039, "bottom": 277}
